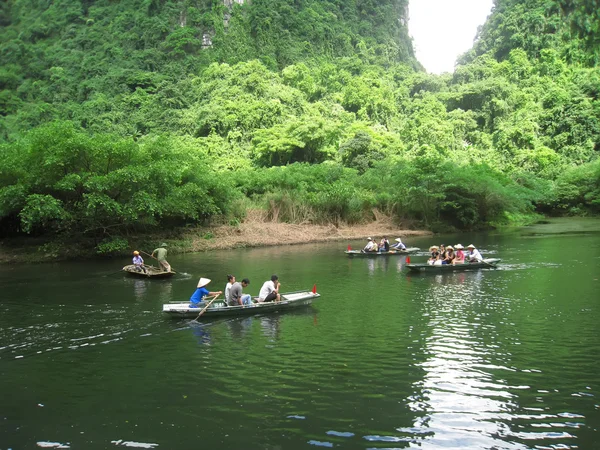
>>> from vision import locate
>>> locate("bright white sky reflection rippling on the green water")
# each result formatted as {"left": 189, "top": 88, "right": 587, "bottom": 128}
{"left": 400, "top": 286, "right": 527, "bottom": 448}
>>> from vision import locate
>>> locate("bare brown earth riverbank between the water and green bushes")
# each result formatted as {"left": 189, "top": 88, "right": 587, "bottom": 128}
{"left": 0, "top": 218, "right": 433, "bottom": 264}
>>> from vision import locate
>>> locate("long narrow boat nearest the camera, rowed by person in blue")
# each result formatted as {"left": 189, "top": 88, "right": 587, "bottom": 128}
{"left": 163, "top": 291, "right": 321, "bottom": 319}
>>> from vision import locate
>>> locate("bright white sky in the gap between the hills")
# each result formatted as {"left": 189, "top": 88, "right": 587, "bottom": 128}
{"left": 408, "top": 0, "right": 493, "bottom": 73}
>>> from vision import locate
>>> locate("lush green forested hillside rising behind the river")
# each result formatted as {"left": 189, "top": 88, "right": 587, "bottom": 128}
{"left": 0, "top": 0, "right": 600, "bottom": 252}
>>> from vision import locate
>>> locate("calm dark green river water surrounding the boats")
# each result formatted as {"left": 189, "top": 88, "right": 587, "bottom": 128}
{"left": 0, "top": 220, "right": 600, "bottom": 450}
